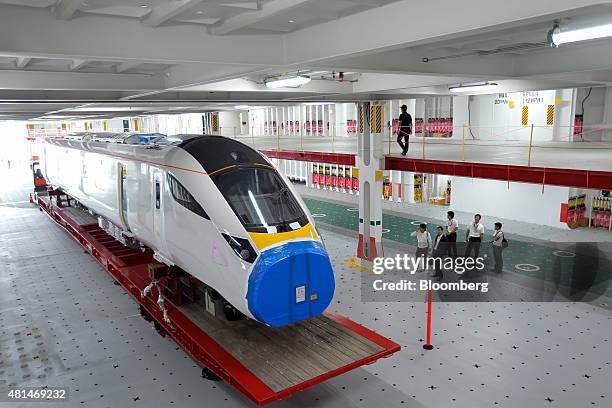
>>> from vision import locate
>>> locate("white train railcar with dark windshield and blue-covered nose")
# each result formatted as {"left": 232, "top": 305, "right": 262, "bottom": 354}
{"left": 41, "top": 136, "right": 334, "bottom": 326}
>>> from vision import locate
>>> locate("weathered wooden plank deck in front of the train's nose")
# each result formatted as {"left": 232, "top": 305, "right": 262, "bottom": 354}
{"left": 180, "top": 303, "right": 384, "bottom": 392}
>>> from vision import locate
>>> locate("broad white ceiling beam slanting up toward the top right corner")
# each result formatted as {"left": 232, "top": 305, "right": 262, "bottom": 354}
{"left": 284, "top": 0, "right": 608, "bottom": 64}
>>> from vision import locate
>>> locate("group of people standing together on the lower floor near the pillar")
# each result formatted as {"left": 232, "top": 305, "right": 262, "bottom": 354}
{"left": 411, "top": 211, "right": 507, "bottom": 279}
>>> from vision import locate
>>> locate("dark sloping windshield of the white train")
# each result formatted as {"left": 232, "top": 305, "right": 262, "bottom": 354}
{"left": 213, "top": 167, "right": 308, "bottom": 233}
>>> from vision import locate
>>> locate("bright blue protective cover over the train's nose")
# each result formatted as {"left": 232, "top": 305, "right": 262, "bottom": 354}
{"left": 247, "top": 241, "right": 334, "bottom": 326}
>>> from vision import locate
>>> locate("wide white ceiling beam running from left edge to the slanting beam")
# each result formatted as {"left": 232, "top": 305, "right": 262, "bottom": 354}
{"left": 0, "top": 5, "right": 283, "bottom": 67}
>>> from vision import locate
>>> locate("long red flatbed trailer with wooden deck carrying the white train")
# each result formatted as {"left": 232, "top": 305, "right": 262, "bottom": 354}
{"left": 37, "top": 196, "right": 400, "bottom": 406}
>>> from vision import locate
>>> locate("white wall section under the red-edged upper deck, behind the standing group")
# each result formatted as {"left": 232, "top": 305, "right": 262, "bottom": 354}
{"left": 450, "top": 177, "right": 569, "bottom": 228}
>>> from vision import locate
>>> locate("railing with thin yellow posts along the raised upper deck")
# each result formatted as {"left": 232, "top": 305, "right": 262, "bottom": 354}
{"left": 385, "top": 124, "right": 612, "bottom": 170}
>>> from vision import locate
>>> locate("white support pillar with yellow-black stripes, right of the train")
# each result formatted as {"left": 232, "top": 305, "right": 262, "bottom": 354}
{"left": 356, "top": 102, "right": 385, "bottom": 265}
